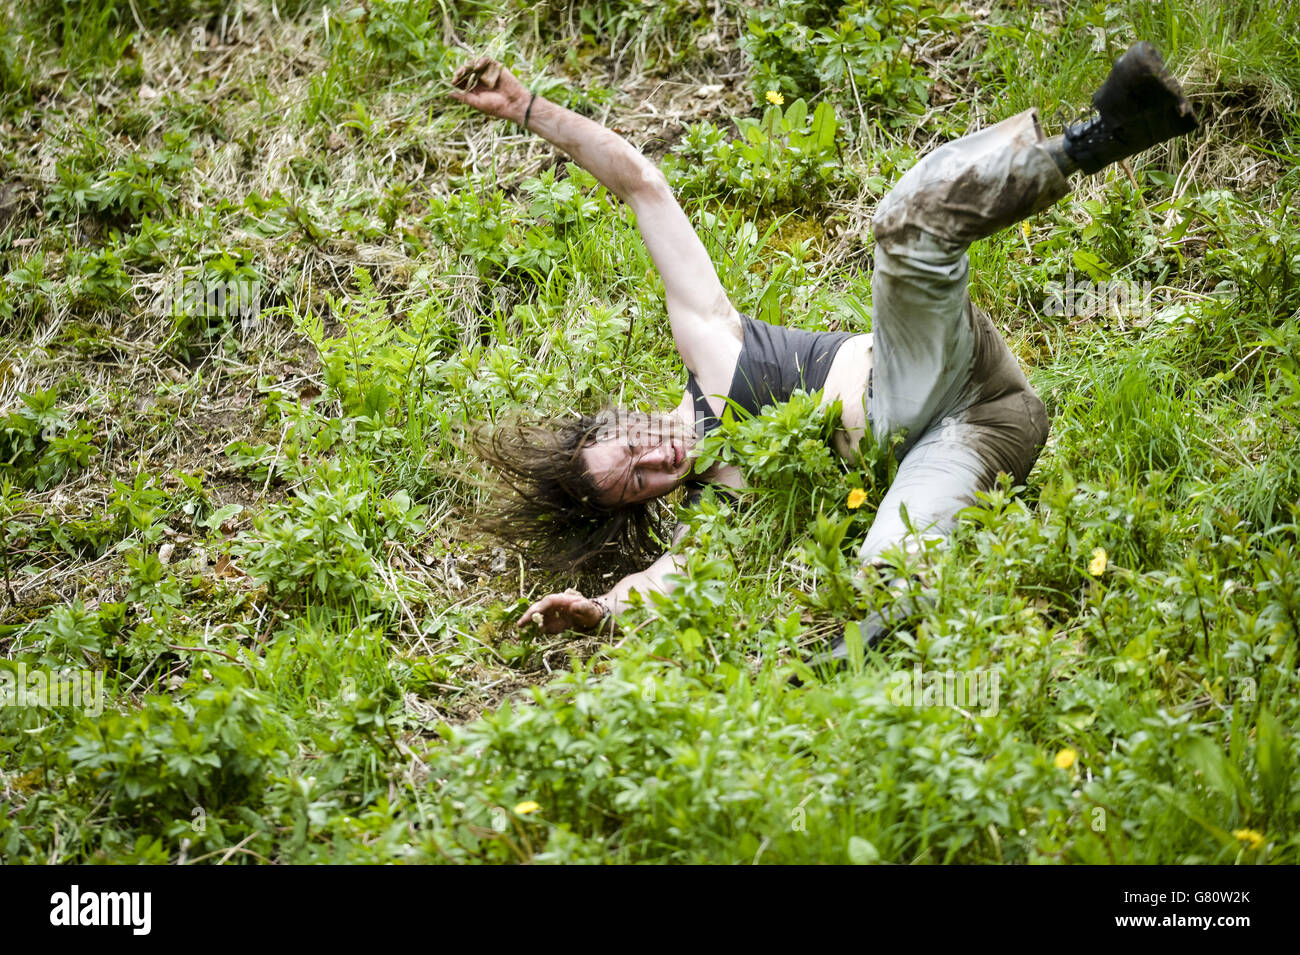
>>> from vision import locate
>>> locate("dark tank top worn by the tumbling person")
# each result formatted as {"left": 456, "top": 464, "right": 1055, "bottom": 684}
{"left": 686, "top": 314, "right": 854, "bottom": 438}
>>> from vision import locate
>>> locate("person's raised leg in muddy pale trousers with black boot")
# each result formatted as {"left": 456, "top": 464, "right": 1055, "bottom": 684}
{"left": 863, "top": 43, "right": 1196, "bottom": 522}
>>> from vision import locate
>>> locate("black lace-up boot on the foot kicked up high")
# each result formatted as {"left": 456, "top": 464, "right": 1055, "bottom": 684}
{"left": 1058, "top": 42, "right": 1197, "bottom": 173}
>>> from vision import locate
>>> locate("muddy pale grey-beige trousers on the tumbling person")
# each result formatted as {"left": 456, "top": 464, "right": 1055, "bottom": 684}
{"left": 859, "top": 109, "right": 1070, "bottom": 563}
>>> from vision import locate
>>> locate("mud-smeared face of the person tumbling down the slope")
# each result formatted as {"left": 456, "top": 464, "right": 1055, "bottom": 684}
{"left": 582, "top": 414, "right": 693, "bottom": 507}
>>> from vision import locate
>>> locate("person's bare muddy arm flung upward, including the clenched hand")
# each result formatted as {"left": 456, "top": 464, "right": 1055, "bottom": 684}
{"left": 451, "top": 57, "right": 741, "bottom": 400}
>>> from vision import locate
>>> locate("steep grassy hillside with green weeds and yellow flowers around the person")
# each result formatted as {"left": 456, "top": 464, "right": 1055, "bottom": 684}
{"left": 0, "top": 0, "right": 1300, "bottom": 863}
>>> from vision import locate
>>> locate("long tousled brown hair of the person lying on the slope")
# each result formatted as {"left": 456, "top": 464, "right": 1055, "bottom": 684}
{"left": 473, "top": 409, "right": 668, "bottom": 573}
